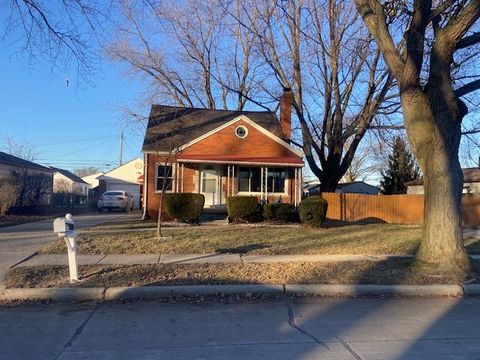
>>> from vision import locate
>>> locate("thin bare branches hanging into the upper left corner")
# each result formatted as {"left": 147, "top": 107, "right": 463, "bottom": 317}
{"left": 0, "top": 0, "right": 110, "bottom": 76}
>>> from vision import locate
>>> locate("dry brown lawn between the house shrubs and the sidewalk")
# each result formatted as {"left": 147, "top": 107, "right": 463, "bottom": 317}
{"left": 40, "top": 224, "right": 420, "bottom": 255}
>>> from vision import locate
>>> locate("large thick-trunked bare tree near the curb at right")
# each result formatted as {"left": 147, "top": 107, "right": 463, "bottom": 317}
{"left": 355, "top": 0, "right": 480, "bottom": 275}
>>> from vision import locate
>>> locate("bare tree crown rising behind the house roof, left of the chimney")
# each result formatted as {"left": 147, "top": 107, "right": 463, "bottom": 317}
{"left": 108, "top": 0, "right": 258, "bottom": 110}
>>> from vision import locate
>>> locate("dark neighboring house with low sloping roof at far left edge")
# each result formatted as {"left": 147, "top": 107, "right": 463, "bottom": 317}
{"left": 0, "top": 151, "right": 53, "bottom": 205}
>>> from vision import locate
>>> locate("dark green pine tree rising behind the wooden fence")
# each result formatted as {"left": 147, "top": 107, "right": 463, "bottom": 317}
{"left": 380, "top": 137, "right": 420, "bottom": 195}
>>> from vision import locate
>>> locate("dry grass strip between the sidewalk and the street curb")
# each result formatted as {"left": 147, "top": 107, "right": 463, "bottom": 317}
{"left": 5, "top": 260, "right": 479, "bottom": 288}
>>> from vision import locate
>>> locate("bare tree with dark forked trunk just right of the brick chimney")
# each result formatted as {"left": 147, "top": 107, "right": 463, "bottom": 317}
{"left": 232, "top": 0, "right": 397, "bottom": 191}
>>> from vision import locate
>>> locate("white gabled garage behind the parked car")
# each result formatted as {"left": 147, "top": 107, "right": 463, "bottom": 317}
{"left": 82, "top": 158, "right": 143, "bottom": 209}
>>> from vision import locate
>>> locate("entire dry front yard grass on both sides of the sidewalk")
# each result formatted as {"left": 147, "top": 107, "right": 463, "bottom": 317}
{"left": 5, "top": 222, "right": 480, "bottom": 287}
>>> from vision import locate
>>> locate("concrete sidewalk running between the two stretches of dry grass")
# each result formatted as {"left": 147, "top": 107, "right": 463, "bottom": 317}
{"left": 16, "top": 253, "right": 480, "bottom": 266}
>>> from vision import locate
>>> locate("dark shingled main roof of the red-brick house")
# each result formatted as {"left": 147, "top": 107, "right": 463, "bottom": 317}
{"left": 142, "top": 105, "right": 288, "bottom": 152}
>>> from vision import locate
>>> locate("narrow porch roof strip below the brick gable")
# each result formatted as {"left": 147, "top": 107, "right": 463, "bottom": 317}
{"left": 177, "top": 154, "right": 304, "bottom": 167}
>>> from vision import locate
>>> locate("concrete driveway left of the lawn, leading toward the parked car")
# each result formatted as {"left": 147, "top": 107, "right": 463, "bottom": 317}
{"left": 0, "top": 212, "right": 140, "bottom": 284}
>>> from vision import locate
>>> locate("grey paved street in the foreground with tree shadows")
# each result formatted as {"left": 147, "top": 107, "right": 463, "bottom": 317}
{"left": 0, "top": 298, "right": 480, "bottom": 360}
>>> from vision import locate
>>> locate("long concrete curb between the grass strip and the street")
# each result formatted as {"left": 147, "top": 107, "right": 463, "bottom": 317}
{"left": 0, "top": 284, "right": 472, "bottom": 302}
